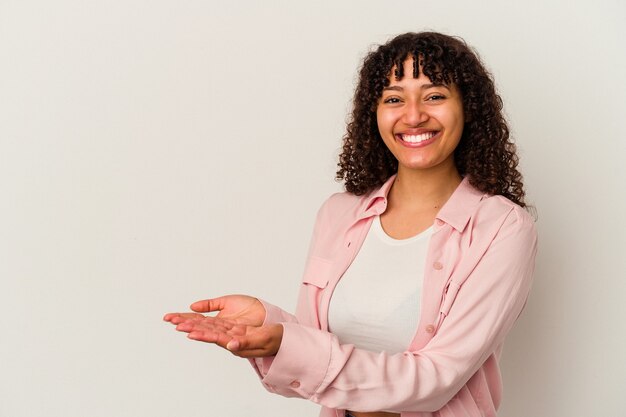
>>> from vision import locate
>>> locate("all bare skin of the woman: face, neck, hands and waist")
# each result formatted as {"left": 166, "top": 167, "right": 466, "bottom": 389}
{"left": 163, "top": 59, "right": 465, "bottom": 417}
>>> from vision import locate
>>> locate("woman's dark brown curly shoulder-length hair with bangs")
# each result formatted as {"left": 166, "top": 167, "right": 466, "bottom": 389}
{"left": 336, "top": 32, "right": 526, "bottom": 207}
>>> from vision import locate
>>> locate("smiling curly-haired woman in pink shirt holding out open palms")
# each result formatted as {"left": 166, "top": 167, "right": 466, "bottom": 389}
{"left": 165, "top": 33, "right": 536, "bottom": 417}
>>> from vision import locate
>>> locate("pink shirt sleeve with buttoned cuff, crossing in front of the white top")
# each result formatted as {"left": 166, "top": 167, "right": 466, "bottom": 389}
{"left": 254, "top": 209, "right": 537, "bottom": 412}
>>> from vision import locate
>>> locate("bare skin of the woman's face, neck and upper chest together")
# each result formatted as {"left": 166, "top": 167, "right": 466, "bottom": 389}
{"left": 376, "top": 59, "right": 465, "bottom": 239}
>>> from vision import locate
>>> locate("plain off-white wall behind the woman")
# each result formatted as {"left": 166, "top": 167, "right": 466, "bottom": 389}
{"left": 0, "top": 0, "right": 626, "bottom": 417}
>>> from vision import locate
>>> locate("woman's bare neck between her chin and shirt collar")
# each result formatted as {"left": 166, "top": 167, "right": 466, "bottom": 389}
{"left": 388, "top": 164, "right": 461, "bottom": 210}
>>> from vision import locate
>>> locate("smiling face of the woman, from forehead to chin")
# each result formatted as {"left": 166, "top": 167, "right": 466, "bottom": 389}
{"left": 376, "top": 58, "right": 464, "bottom": 173}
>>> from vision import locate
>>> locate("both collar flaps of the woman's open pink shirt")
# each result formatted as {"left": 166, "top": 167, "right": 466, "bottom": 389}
{"left": 360, "top": 175, "right": 485, "bottom": 232}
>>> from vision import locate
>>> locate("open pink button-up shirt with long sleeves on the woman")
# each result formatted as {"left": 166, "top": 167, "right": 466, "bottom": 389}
{"left": 252, "top": 177, "right": 537, "bottom": 417}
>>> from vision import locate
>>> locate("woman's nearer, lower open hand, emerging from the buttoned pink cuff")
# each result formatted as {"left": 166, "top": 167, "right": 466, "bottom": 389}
{"left": 167, "top": 314, "right": 283, "bottom": 358}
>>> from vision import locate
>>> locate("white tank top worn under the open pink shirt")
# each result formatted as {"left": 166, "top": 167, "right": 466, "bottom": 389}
{"left": 328, "top": 216, "right": 432, "bottom": 353}
